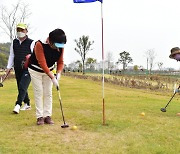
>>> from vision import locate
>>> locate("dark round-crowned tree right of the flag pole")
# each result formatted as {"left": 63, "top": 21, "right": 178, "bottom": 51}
{"left": 117, "top": 51, "right": 133, "bottom": 70}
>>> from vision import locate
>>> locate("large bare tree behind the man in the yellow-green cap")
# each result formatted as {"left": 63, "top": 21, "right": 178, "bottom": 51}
{"left": 0, "top": 0, "right": 31, "bottom": 42}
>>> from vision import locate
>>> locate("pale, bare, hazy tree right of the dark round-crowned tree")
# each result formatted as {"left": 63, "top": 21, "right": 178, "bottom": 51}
{"left": 145, "top": 49, "right": 155, "bottom": 74}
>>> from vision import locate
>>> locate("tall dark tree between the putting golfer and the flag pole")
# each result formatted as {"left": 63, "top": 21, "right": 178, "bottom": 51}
{"left": 74, "top": 35, "right": 94, "bottom": 74}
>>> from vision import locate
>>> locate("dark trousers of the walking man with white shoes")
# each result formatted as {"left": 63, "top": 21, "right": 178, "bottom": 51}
{"left": 15, "top": 69, "right": 31, "bottom": 106}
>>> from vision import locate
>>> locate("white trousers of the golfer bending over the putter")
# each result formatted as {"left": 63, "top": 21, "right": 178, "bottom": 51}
{"left": 28, "top": 68, "right": 53, "bottom": 118}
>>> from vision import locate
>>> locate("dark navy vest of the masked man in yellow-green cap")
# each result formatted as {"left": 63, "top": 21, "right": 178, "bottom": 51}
{"left": 13, "top": 38, "right": 33, "bottom": 69}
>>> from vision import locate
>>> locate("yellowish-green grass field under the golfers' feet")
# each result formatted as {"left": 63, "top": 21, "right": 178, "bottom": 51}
{"left": 0, "top": 76, "right": 180, "bottom": 154}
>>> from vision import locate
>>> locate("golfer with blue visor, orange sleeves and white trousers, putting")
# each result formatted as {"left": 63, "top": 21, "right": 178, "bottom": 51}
{"left": 28, "top": 29, "right": 66, "bottom": 125}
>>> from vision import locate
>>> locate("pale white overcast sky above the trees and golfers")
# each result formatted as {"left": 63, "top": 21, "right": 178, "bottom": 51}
{"left": 0, "top": 0, "right": 180, "bottom": 69}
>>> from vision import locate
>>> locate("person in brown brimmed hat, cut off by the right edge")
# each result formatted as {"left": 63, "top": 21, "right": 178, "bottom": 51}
{"left": 169, "top": 47, "right": 180, "bottom": 116}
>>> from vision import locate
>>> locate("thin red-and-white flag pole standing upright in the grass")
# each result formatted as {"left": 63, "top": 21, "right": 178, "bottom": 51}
{"left": 101, "top": 3, "right": 106, "bottom": 125}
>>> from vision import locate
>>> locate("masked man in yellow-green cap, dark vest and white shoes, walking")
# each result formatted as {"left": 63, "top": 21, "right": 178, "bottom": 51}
{"left": 6, "top": 23, "right": 34, "bottom": 114}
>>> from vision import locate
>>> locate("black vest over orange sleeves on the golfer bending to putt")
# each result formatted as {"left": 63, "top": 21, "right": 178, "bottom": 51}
{"left": 29, "top": 41, "right": 62, "bottom": 73}
